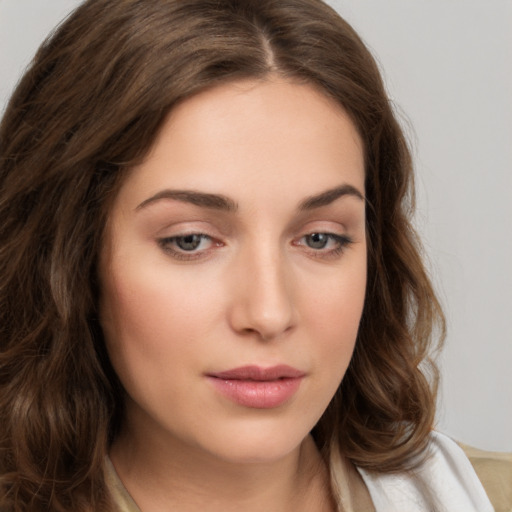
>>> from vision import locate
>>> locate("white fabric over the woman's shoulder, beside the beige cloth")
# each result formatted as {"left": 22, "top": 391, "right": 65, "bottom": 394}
{"left": 360, "top": 432, "right": 494, "bottom": 512}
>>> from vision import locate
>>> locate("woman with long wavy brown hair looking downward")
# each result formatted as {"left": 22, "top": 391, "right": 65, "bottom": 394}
{"left": 0, "top": 0, "right": 492, "bottom": 512}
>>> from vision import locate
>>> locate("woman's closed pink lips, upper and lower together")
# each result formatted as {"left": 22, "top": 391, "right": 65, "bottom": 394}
{"left": 207, "top": 365, "right": 306, "bottom": 409}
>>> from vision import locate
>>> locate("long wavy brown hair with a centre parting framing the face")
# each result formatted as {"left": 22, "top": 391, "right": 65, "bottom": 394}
{"left": 0, "top": 0, "right": 444, "bottom": 511}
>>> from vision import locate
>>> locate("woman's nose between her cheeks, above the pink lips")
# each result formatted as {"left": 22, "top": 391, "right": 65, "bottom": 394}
{"left": 229, "top": 250, "right": 297, "bottom": 340}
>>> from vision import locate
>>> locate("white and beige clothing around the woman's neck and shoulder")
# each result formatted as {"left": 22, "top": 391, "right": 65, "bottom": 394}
{"left": 106, "top": 432, "right": 512, "bottom": 512}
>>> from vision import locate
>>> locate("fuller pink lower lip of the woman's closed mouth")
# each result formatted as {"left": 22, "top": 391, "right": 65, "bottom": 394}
{"left": 208, "top": 377, "right": 303, "bottom": 409}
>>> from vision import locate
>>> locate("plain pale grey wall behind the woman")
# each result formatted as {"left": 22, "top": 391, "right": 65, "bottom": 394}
{"left": 0, "top": 0, "right": 512, "bottom": 451}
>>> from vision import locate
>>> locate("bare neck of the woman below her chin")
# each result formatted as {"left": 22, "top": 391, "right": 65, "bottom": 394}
{"left": 110, "top": 426, "right": 334, "bottom": 512}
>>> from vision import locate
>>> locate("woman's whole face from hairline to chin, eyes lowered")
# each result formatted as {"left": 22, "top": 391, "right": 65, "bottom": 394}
{"left": 100, "top": 80, "right": 366, "bottom": 462}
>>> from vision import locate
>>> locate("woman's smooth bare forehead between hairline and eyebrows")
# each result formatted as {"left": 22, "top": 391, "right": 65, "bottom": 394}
{"left": 114, "top": 80, "right": 364, "bottom": 210}
